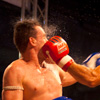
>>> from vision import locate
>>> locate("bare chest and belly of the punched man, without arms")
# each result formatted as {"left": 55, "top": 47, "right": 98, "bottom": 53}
{"left": 23, "top": 60, "right": 62, "bottom": 100}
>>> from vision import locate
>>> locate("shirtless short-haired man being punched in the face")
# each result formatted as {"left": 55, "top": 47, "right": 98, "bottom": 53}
{"left": 2, "top": 19, "right": 76, "bottom": 100}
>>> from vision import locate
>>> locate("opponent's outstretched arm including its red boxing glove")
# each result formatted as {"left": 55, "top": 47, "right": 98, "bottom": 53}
{"left": 43, "top": 36, "right": 100, "bottom": 87}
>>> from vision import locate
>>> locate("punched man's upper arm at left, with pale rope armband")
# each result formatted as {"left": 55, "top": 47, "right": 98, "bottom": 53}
{"left": 2, "top": 64, "right": 23, "bottom": 100}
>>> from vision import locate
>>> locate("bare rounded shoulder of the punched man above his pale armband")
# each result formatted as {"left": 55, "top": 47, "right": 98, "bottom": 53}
{"left": 3, "top": 60, "right": 25, "bottom": 86}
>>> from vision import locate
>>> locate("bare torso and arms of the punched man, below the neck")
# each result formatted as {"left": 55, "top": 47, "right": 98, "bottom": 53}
{"left": 2, "top": 60, "right": 76, "bottom": 100}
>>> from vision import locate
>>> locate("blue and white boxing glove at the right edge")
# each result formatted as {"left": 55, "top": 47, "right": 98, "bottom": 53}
{"left": 82, "top": 52, "right": 100, "bottom": 69}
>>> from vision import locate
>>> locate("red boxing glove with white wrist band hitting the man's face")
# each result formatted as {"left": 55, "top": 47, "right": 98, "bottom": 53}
{"left": 42, "top": 36, "right": 73, "bottom": 71}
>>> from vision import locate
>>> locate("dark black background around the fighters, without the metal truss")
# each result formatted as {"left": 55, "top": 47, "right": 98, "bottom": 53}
{"left": 0, "top": 0, "right": 100, "bottom": 100}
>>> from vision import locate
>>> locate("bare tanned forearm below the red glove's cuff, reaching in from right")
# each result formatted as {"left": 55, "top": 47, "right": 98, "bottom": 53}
{"left": 68, "top": 62, "right": 100, "bottom": 87}
